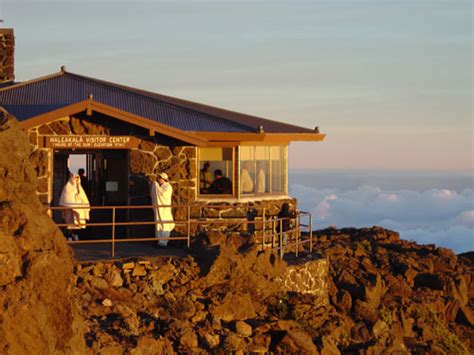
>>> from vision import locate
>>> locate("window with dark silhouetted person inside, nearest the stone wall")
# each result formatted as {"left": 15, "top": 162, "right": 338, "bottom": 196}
{"left": 198, "top": 148, "right": 234, "bottom": 195}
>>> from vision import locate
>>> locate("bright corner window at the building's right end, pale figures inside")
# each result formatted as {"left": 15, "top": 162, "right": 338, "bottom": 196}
{"left": 240, "top": 146, "right": 286, "bottom": 195}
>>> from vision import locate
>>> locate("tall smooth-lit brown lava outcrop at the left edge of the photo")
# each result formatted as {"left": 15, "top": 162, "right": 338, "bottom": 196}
{"left": 0, "top": 109, "right": 85, "bottom": 354}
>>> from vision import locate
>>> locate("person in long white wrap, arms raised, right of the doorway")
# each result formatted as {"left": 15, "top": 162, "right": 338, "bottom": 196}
{"left": 150, "top": 173, "right": 175, "bottom": 247}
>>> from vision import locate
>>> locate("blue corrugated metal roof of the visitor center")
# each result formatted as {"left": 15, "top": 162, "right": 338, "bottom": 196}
{"left": 0, "top": 72, "right": 314, "bottom": 133}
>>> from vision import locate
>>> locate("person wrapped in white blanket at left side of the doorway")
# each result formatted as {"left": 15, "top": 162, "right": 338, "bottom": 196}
{"left": 59, "top": 173, "right": 90, "bottom": 240}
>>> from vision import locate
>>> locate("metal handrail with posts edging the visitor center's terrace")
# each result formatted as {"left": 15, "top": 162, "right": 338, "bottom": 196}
{"left": 47, "top": 204, "right": 313, "bottom": 258}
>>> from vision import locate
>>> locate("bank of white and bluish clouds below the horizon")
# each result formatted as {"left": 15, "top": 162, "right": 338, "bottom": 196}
{"left": 290, "top": 184, "right": 474, "bottom": 253}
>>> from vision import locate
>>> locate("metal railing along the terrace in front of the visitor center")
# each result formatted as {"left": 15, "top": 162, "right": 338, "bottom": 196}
{"left": 47, "top": 204, "right": 313, "bottom": 258}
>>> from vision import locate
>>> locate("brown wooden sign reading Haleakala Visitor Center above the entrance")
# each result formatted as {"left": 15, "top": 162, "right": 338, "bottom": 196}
{"left": 43, "top": 135, "right": 140, "bottom": 149}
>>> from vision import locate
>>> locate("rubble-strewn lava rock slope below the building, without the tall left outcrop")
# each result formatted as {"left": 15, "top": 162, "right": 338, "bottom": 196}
{"left": 76, "top": 227, "right": 474, "bottom": 354}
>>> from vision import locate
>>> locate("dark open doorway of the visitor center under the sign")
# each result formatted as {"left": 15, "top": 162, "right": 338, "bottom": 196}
{"left": 52, "top": 150, "right": 130, "bottom": 239}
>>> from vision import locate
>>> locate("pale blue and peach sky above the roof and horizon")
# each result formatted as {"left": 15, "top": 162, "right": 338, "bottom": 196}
{"left": 0, "top": 0, "right": 474, "bottom": 171}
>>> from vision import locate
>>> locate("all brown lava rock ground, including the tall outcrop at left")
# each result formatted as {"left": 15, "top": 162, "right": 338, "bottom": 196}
{"left": 0, "top": 110, "right": 474, "bottom": 354}
